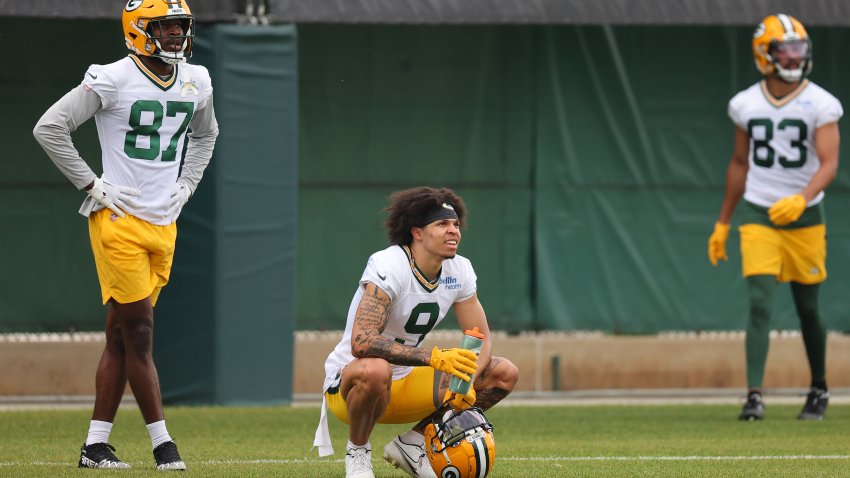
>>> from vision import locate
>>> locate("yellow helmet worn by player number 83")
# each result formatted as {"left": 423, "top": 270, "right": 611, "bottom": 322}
{"left": 753, "top": 13, "right": 812, "bottom": 83}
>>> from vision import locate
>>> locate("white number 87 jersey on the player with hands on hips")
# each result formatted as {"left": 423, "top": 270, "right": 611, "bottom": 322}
{"left": 82, "top": 55, "right": 212, "bottom": 225}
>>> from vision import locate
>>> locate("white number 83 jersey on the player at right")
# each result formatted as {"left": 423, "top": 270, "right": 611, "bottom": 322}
{"left": 729, "top": 80, "right": 844, "bottom": 207}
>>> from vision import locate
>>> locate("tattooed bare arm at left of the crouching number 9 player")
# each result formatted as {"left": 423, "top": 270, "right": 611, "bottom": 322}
{"left": 351, "top": 284, "right": 431, "bottom": 366}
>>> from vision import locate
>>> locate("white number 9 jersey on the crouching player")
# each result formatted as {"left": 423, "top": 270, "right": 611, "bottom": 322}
{"left": 323, "top": 246, "right": 477, "bottom": 390}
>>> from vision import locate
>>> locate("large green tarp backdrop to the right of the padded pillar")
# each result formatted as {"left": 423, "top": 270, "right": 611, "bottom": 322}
{"left": 297, "top": 25, "right": 850, "bottom": 333}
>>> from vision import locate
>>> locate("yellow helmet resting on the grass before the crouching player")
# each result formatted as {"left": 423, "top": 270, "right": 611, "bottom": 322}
{"left": 425, "top": 407, "right": 496, "bottom": 478}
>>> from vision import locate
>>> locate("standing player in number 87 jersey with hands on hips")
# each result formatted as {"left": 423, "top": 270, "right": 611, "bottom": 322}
{"left": 33, "top": 0, "right": 218, "bottom": 470}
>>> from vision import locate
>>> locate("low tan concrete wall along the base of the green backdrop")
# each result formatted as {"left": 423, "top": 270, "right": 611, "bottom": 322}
{"left": 0, "top": 332, "right": 850, "bottom": 398}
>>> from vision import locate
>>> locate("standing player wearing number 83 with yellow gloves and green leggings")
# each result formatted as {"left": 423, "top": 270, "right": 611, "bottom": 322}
{"left": 708, "top": 14, "right": 843, "bottom": 420}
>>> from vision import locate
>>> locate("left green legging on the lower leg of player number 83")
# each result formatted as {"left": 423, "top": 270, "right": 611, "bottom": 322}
{"left": 744, "top": 275, "right": 776, "bottom": 389}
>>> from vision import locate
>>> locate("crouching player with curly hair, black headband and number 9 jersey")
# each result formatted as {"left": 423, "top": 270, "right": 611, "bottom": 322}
{"left": 313, "top": 187, "right": 519, "bottom": 478}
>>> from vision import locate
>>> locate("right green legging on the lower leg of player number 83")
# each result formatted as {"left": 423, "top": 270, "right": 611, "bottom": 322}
{"left": 791, "top": 282, "right": 826, "bottom": 384}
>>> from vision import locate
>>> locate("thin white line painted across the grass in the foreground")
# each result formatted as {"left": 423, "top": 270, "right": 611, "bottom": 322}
{"left": 0, "top": 455, "right": 850, "bottom": 467}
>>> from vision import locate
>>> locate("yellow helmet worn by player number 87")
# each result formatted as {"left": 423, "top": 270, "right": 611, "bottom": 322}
{"left": 121, "top": 0, "right": 195, "bottom": 64}
